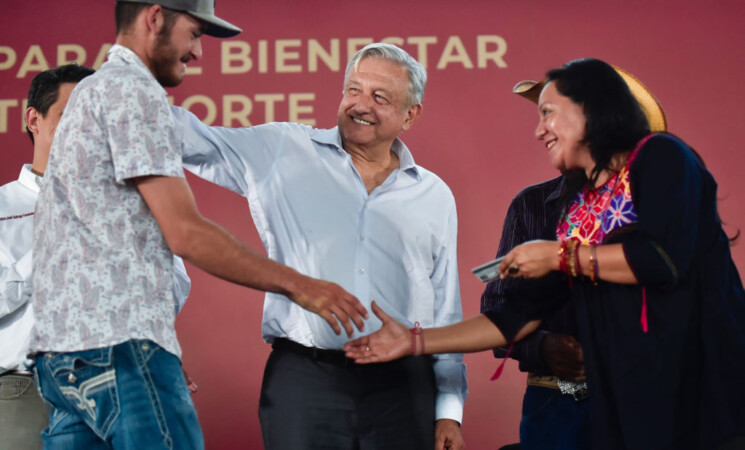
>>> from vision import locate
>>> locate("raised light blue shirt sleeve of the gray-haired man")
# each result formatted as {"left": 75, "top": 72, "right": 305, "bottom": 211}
{"left": 171, "top": 106, "right": 288, "bottom": 197}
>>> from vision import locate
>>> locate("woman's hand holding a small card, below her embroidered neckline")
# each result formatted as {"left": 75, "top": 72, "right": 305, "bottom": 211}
{"left": 499, "top": 240, "right": 561, "bottom": 279}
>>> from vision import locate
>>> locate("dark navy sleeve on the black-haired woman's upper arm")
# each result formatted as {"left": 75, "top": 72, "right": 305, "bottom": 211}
{"left": 620, "top": 135, "right": 704, "bottom": 286}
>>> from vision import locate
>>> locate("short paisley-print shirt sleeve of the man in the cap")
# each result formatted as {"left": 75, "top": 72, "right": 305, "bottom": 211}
{"left": 101, "top": 76, "right": 184, "bottom": 184}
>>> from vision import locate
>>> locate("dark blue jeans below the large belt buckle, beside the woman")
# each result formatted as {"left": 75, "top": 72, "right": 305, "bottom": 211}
{"left": 520, "top": 386, "right": 592, "bottom": 450}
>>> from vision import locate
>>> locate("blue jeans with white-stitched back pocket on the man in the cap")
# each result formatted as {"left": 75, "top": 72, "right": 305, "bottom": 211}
{"left": 34, "top": 340, "right": 204, "bottom": 450}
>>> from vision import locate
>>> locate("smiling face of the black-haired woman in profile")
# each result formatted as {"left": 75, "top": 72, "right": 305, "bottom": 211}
{"left": 535, "top": 82, "right": 595, "bottom": 171}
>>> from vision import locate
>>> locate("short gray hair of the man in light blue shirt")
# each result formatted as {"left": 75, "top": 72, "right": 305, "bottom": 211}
{"left": 344, "top": 42, "right": 427, "bottom": 107}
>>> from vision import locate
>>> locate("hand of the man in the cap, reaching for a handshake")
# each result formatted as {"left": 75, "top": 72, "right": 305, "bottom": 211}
{"left": 290, "top": 276, "right": 368, "bottom": 337}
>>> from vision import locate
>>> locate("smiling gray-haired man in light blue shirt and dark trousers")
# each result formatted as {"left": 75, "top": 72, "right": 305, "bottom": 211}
{"left": 173, "top": 44, "right": 467, "bottom": 450}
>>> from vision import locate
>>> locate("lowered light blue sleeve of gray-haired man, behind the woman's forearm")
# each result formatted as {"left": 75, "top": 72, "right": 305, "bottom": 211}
{"left": 430, "top": 198, "right": 468, "bottom": 422}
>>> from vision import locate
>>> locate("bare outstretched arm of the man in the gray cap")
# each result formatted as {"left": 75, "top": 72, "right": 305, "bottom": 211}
{"left": 135, "top": 176, "right": 367, "bottom": 337}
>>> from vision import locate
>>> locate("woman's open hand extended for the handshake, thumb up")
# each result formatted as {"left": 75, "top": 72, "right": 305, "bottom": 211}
{"left": 344, "top": 302, "right": 414, "bottom": 364}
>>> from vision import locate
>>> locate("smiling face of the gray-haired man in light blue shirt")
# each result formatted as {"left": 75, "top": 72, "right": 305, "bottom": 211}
{"left": 338, "top": 57, "right": 422, "bottom": 150}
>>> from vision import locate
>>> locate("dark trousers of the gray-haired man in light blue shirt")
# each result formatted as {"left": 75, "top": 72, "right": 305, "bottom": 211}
{"left": 259, "top": 341, "right": 436, "bottom": 450}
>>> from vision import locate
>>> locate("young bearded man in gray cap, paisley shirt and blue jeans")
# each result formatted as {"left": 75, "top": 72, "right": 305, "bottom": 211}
{"left": 31, "top": 0, "right": 366, "bottom": 449}
